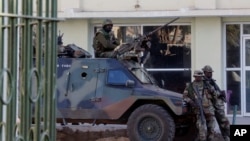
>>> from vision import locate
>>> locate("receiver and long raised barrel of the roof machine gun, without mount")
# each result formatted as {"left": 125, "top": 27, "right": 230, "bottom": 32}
{"left": 115, "top": 17, "right": 179, "bottom": 55}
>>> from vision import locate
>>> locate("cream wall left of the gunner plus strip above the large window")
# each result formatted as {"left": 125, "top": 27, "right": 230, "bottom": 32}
{"left": 58, "top": 18, "right": 192, "bottom": 53}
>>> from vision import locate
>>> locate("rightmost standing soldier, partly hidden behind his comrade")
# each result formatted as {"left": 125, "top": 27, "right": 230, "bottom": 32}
{"left": 202, "top": 65, "right": 230, "bottom": 141}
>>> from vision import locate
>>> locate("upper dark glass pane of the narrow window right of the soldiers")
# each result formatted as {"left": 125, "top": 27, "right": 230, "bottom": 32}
{"left": 226, "top": 24, "right": 241, "bottom": 68}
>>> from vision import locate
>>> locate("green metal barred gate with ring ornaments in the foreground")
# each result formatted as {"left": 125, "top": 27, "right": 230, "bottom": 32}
{"left": 0, "top": 0, "right": 58, "bottom": 141}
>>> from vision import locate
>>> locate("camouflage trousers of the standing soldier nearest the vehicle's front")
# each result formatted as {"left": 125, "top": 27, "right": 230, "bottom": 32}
{"left": 196, "top": 108, "right": 216, "bottom": 141}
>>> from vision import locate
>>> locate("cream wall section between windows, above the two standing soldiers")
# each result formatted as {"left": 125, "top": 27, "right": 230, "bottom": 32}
{"left": 192, "top": 17, "right": 223, "bottom": 86}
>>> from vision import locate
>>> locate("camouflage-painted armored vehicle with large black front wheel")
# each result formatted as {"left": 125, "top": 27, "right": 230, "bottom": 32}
{"left": 57, "top": 58, "right": 196, "bottom": 141}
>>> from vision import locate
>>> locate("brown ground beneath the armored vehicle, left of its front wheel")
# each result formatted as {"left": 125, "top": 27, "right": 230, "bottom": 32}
{"left": 56, "top": 124, "right": 223, "bottom": 141}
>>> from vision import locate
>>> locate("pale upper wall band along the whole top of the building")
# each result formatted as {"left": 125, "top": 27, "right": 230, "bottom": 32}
{"left": 58, "top": 0, "right": 250, "bottom": 12}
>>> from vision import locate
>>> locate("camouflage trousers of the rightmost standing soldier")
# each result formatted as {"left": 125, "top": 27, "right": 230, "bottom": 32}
{"left": 214, "top": 99, "right": 230, "bottom": 140}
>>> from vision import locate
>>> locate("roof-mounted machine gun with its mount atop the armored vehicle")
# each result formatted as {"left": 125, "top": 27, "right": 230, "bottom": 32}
{"left": 115, "top": 17, "right": 179, "bottom": 63}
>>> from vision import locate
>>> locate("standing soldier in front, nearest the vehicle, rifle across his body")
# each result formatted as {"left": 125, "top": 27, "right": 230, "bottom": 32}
{"left": 183, "top": 70, "right": 215, "bottom": 141}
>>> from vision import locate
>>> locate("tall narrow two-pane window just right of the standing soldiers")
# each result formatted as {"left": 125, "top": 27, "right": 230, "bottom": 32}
{"left": 226, "top": 24, "right": 242, "bottom": 114}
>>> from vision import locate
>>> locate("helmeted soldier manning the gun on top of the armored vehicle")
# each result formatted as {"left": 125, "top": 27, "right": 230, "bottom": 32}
{"left": 93, "top": 19, "right": 120, "bottom": 58}
